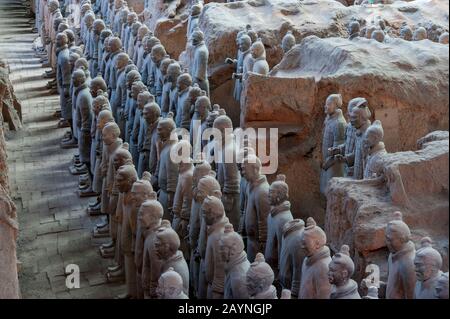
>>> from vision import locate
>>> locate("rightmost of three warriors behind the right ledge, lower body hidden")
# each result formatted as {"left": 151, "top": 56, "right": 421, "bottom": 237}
{"left": 363, "top": 120, "right": 387, "bottom": 179}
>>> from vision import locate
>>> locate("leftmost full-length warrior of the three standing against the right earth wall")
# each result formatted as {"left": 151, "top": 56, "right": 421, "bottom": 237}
{"left": 320, "top": 94, "right": 347, "bottom": 194}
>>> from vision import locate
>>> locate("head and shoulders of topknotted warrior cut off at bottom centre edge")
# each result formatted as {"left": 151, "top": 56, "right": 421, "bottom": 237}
{"left": 246, "top": 253, "right": 278, "bottom": 299}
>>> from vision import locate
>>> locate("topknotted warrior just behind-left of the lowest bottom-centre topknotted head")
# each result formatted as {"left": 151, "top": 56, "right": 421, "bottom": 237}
{"left": 219, "top": 224, "right": 250, "bottom": 299}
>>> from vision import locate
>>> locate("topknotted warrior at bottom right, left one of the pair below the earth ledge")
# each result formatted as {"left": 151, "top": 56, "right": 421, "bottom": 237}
{"left": 386, "top": 212, "right": 416, "bottom": 299}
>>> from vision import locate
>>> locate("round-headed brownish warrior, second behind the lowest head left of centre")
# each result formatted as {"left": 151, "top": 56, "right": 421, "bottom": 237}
{"left": 142, "top": 199, "right": 163, "bottom": 299}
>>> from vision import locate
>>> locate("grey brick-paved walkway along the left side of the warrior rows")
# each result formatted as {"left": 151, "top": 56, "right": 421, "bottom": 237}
{"left": 0, "top": 0, "right": 124, "bottom": 298}
